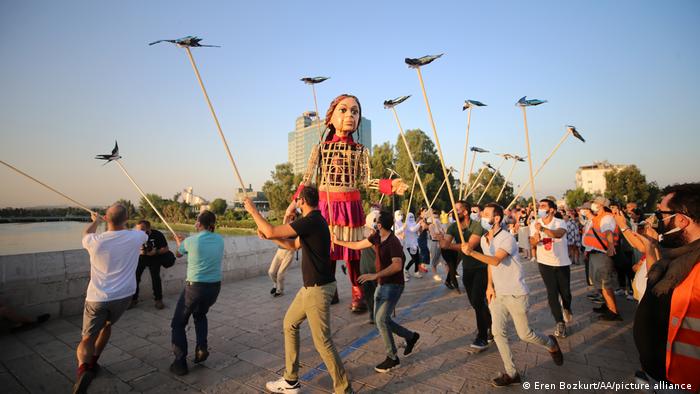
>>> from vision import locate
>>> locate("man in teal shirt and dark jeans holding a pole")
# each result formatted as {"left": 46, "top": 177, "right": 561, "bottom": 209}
{"left": 170, "top": 211, "right": 224, "bottom": 376}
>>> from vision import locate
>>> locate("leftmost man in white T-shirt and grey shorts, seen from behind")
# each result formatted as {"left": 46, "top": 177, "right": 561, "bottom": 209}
{"left": 73, "top": 204, "right": 148, "bottom": 393}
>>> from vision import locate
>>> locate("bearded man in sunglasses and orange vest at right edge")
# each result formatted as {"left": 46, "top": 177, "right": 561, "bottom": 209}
{"left": 636, "top": 183, "right": 700, "bottom": 392}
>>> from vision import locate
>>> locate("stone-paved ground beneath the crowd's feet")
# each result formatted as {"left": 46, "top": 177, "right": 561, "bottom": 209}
{"left": 0, "top": 262, "right": 638, "bottom": 394}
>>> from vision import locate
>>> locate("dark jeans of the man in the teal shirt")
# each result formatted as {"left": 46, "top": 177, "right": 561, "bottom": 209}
{"left": 170, "top": 282, "right": 221, "bottom": 360}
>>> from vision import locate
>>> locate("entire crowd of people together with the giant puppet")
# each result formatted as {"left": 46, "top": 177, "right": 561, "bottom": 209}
{"left": 56, "top": 89, "right": 700, "bottom": 393}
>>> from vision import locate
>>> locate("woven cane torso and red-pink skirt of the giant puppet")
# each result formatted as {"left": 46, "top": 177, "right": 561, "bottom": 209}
{"left": 304, "top": 142, "right": 370, "bottom": 261}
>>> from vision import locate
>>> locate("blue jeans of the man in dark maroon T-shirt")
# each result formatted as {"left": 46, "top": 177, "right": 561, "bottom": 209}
{"left": 374, "top": 284, "right": 414, "bottom": 360}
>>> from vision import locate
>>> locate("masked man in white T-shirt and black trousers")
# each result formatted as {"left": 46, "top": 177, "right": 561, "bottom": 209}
{"left": 530, "top": 198, "right": 573, "bottom": 338}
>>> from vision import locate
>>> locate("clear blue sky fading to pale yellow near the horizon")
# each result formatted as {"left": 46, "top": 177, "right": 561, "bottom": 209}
{"left": 0, "top": 0, "right": 700, "bottom": 207}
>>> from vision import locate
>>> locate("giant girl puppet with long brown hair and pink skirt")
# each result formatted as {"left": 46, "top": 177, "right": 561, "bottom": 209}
{"left": 290, "top": 94, "right": 408, "bottom": 312}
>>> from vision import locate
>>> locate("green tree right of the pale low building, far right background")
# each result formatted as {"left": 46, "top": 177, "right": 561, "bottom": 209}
{"left": 605, "top": 165, "right": 659, "bottom": 211}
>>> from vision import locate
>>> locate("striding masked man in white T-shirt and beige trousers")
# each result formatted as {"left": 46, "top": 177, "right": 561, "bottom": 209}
{"left": 461, "top": 203, "right": 564, "bottom": 387}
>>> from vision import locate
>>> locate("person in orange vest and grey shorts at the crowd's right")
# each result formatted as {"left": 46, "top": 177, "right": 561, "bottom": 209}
{"left": 583, "top": 197, "right": 622, "bottom": 321}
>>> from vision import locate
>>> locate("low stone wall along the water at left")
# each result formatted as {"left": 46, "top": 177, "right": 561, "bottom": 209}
{"left": 0, "top": 236, "right": 296, "bottom": 316}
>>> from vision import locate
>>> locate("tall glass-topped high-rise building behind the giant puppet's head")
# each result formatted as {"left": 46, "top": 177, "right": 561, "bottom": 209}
{"left": 287, "top": 111, "right": 372, "bottom": 174}
